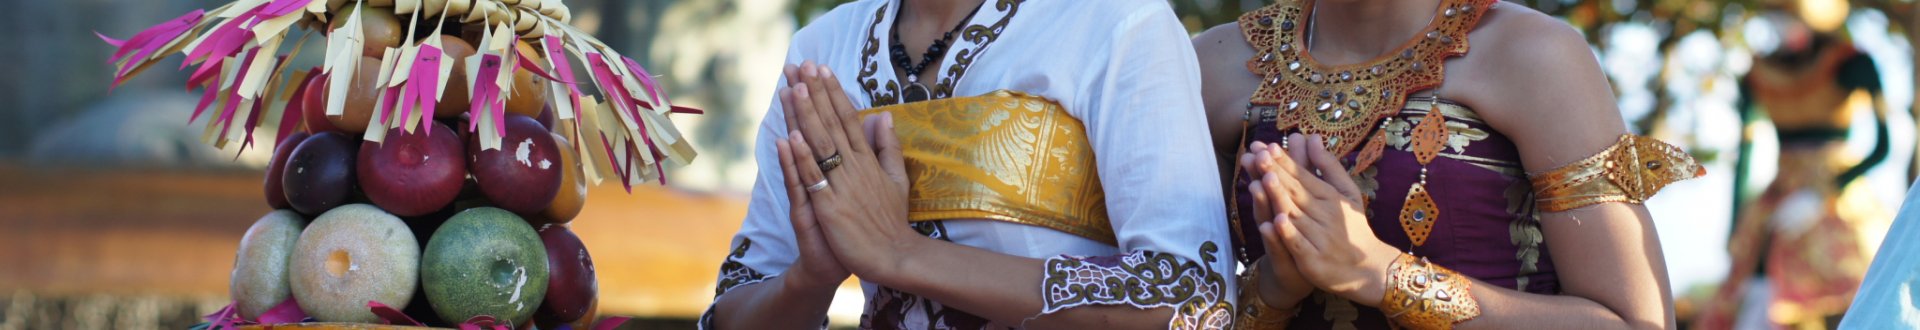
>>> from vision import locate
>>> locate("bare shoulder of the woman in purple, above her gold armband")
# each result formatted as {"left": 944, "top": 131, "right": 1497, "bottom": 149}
{"left": 1450, "top": 2, "right": 1626, "bottom": 171}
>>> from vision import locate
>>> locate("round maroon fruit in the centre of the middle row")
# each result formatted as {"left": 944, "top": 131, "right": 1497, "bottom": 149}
{"left": 357, "top": 123, "right": 467, "bottom": 217}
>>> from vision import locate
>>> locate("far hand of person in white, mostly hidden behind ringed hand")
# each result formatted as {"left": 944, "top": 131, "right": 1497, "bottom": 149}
{"left": 774, "top": 65, "right": 851, "bottom": 290}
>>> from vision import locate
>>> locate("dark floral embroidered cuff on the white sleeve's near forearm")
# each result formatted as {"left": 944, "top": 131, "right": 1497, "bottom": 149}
{"left": 1041, "top": 242, "right": 1233, "bottom": 328}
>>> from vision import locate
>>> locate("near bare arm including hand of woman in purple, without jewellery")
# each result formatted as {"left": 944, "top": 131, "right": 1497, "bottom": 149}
{"left": 1261, "top": 6, "right": 1674, "bottom": 328}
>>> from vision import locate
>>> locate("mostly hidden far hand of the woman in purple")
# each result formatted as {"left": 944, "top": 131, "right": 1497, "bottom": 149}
{"left": 1240, "top": 142, "right": 1313, "bottom": 311}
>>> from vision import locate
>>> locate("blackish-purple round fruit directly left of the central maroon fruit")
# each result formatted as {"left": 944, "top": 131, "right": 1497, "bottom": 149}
{"left": 280, "top": 132, "right": 359, "bottom": 215}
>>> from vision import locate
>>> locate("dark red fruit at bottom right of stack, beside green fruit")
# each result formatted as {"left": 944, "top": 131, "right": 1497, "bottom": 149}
{"left": 534, "top": 224, "right": 599, "bottom": 322}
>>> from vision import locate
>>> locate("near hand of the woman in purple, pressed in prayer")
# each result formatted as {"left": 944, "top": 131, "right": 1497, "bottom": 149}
{"left": 1256, "top": 134, "right": 1402, "bottom": 307}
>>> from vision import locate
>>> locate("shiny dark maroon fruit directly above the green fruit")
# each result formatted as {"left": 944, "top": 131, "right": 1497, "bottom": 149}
{"left": 467, "top": 113, "right": 564, "bottom": 217}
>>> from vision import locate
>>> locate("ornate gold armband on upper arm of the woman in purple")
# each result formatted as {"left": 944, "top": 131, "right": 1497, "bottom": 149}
{"left": 1530, "top": 134, "right": 1707, "bottom": 213}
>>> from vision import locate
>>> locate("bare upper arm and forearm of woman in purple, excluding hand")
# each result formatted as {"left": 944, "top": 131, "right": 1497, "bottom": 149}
{"left": 1463, "top": 6, "right": 1674, "bottom": 328}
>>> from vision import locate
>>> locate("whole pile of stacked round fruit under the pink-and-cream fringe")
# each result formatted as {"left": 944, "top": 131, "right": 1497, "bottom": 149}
{"left": 232, "top": 10, "right": 597, "bottom": 324}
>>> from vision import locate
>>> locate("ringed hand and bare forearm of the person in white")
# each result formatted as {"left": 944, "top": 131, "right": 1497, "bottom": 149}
{"left": 780, "top": 65, "right": 1221, "bottom": 328}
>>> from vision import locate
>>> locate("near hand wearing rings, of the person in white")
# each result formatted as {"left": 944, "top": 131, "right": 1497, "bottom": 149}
{"left": 781, "top": 63, "right": 925, "bottom": 278}
